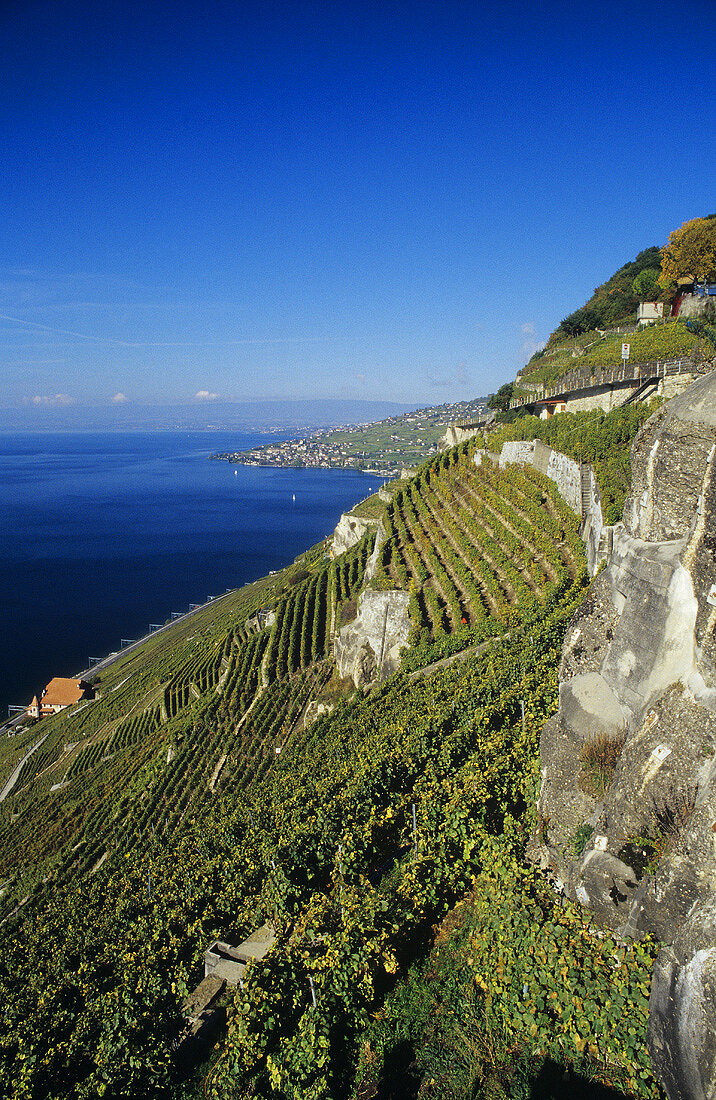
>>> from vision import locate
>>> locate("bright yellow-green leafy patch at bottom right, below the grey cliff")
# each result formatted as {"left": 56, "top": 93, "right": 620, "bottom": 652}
{"left": 356, "top": 849, "right": 660, "bottom": 1098}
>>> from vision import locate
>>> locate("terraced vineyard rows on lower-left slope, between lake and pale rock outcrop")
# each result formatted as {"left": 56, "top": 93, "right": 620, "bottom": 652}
{"left": 0, "top": 519, "right": 380, "bottom": 897}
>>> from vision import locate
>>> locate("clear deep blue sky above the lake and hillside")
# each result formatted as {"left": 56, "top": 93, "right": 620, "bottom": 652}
{"left": 0, "top": 0, "right": 716, "bottom": 416}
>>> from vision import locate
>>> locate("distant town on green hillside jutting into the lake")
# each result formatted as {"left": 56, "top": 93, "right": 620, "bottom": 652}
{"left": 213, "top": 398, "right": 486, "bottom": 476}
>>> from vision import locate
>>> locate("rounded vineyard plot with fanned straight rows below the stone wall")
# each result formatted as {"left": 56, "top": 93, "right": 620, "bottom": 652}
{"left": 376, "top": 444, "right": 582, "bottom": 639}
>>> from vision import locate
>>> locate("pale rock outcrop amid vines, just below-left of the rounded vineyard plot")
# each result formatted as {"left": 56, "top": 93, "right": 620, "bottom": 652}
{"left": 335, "top": 589, "right": 410, "bottom": 688}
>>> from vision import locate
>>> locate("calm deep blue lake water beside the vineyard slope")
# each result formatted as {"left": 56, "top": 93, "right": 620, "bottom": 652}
{"left": 0, "top": 431, "right": 378, "bottom": 719}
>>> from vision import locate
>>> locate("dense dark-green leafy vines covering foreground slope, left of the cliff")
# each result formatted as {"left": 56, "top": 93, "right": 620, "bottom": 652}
{"left": 0, "top": 563, "right": 580, "bottom": 1098}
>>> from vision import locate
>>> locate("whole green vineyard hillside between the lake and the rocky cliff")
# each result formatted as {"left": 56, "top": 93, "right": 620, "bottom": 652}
{"left": 0, "top": 429, "right": 656, "bottom": 1100}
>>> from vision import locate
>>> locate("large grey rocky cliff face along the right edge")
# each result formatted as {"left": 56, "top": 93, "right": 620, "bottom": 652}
{"left": 531, "top": 374, "right": 716, "bottom": 1100}
